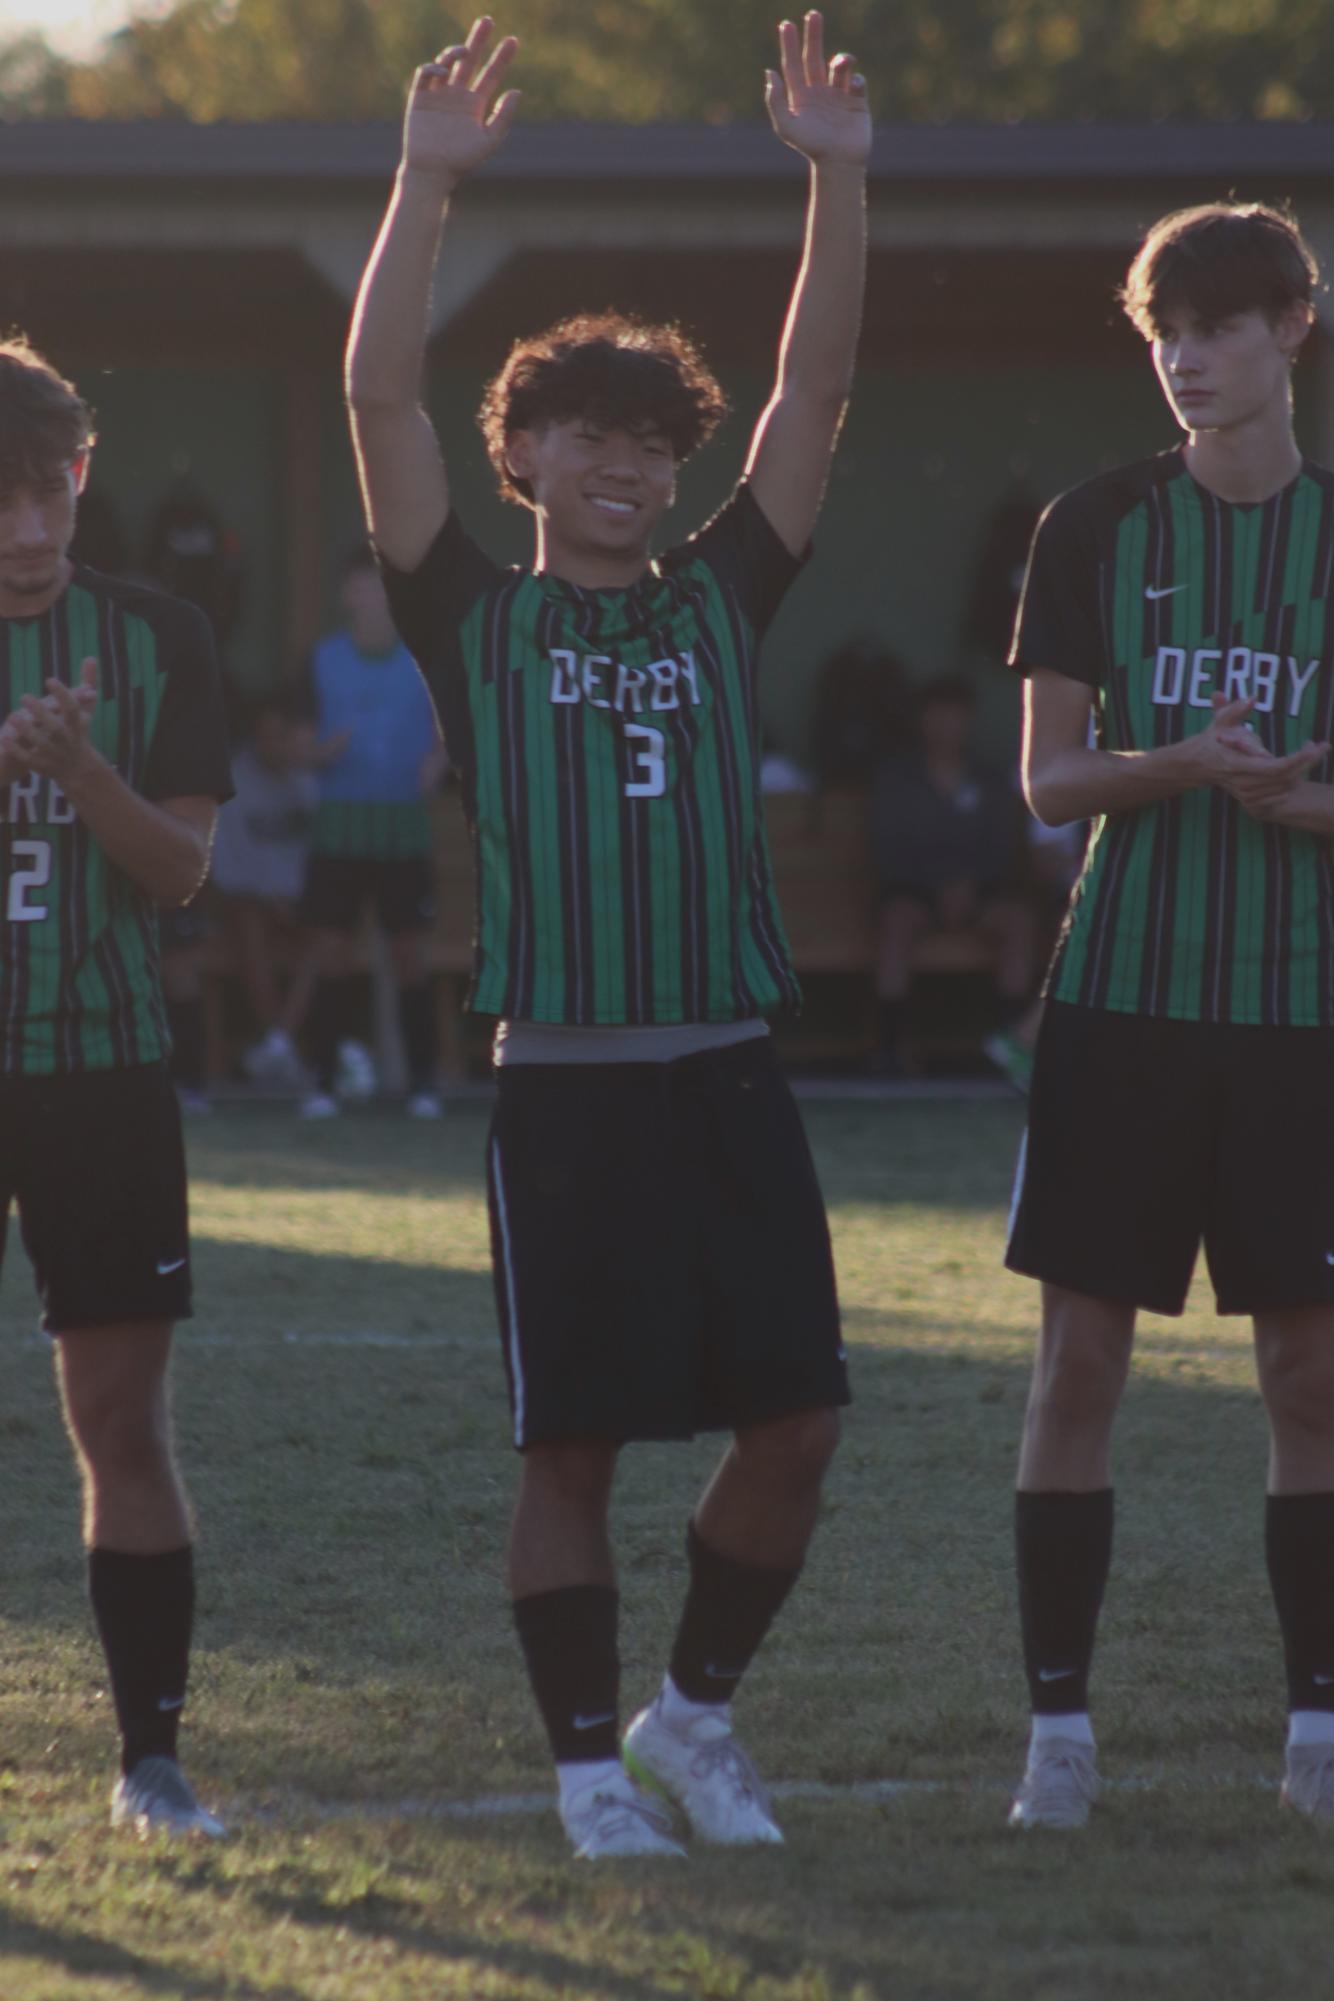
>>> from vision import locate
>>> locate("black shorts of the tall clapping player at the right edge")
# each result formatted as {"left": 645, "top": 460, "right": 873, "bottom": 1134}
{"left": 1006, "top": 1001, "right": 1334, "bottom": 1313}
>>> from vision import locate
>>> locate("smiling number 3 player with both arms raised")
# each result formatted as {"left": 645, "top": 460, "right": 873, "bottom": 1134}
{"left": 348, "top": 14, "right": 870, "bottom": 1857}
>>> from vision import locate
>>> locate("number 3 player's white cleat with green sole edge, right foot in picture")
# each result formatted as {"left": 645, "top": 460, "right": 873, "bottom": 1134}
{"left": 620, "top": 1701, "right": 782, "bottom": 1847}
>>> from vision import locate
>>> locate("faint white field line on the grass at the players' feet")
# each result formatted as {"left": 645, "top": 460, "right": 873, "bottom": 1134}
{"left": 245, "top": 1773, "right": 1278, "bottom": 1823}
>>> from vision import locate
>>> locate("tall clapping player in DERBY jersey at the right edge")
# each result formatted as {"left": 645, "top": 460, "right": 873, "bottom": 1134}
{"left": 1008, "top": 204, "right": 1334, "bottom": 1827}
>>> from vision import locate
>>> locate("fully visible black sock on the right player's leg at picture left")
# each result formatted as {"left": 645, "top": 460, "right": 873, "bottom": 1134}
{"left": 1014, "top": 1487, "right": 1112, "bottom": 1717}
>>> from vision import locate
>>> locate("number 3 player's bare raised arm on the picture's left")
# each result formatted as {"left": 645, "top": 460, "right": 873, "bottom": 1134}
{"left": 348, "top": 16, "right": 518, "bottom": 570}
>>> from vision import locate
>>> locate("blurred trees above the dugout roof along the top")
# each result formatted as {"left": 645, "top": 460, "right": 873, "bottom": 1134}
{"left": 0, "top": 0, "right": 1334, "bottom": 122}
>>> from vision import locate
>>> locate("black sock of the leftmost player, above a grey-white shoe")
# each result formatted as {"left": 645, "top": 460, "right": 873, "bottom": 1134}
{"left": 88, "top": 1543, "right": 194, "bottom": 1771}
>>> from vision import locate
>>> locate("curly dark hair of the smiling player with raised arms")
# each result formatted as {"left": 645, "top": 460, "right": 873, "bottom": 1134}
{"left": 478, "top": 312, "right": 728, "bottom": 506}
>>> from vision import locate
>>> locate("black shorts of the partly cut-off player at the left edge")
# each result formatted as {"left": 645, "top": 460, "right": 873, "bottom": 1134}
{"left": 0, "top": 1063, "right": 190, "bottom": 1335}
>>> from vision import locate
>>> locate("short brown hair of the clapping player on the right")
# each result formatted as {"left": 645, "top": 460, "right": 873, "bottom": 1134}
{"left": 1118, "top": 202, "right": 1320, "bottom": 340}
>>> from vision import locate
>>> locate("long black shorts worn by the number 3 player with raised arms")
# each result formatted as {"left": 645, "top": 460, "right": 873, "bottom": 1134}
{"left": 488, "top": 1039, "right": 850, "bottom": 1449}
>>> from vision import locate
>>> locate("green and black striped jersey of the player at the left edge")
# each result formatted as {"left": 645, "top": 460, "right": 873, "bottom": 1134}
{"left": 0, "top": 566, "right": 232, "bottom": 1077}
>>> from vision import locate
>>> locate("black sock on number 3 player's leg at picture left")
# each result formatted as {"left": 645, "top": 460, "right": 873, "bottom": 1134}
{"left": 514, "top": 1585, "right": 620, "bottom": 1765}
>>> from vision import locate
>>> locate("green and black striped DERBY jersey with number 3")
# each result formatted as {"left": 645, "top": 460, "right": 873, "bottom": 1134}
{"left": 386, "top": 484, "right": 800, "bottom": 1027}
